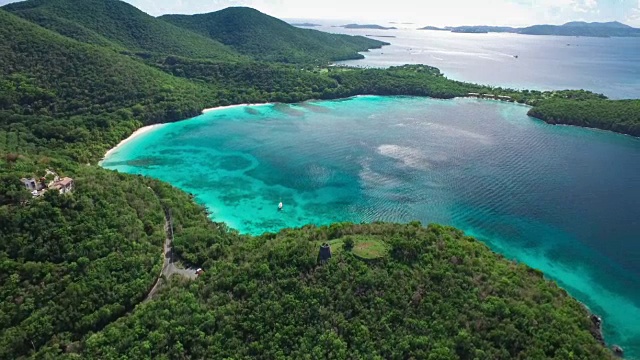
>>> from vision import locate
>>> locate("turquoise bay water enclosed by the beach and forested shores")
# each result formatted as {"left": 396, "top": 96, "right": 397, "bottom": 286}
{"left": 102, "top": 96, "right": 640, "bottom": 358}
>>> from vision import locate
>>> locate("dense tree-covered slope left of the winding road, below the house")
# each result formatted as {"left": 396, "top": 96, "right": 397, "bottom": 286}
{"left": 0, "top": 168, "right": 165, "bottom": 359}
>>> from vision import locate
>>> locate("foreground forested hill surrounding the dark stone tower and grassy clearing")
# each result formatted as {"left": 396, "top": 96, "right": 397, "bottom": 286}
{"left": 77, "top": 223, "right": 611, "bottom": 359}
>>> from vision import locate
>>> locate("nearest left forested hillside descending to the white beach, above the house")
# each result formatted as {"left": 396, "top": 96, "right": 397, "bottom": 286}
{"left": 0, "top": 6, "right": 220, "bottom": 162}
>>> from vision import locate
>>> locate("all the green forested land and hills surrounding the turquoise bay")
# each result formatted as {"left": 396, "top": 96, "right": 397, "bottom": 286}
{"left": 0, "top": 0, "right": 640, "bottom": 359}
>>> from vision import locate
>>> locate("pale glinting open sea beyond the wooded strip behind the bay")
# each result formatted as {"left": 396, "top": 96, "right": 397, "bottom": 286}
{"left": 318, "top": 26, "right": 640, "bottom": 99}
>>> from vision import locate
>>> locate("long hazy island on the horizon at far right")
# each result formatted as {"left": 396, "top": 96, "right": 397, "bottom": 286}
{"left": 418, "top": 21, "right": 640, "bottom": 37}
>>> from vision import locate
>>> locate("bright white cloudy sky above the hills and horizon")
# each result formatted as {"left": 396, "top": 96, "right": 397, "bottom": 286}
{"left": 0, "top": 0, "right": 640, "bottom": 27}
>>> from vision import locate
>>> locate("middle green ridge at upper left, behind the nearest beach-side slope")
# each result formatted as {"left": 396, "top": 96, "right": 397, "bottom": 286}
{"left": 4, "top": 0, "right": 239, "bottom": 61}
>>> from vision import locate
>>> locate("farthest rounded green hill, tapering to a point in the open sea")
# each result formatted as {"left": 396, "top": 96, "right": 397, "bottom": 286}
{"left": 160, "top": 7, "right": 385, "bottom": 63}
